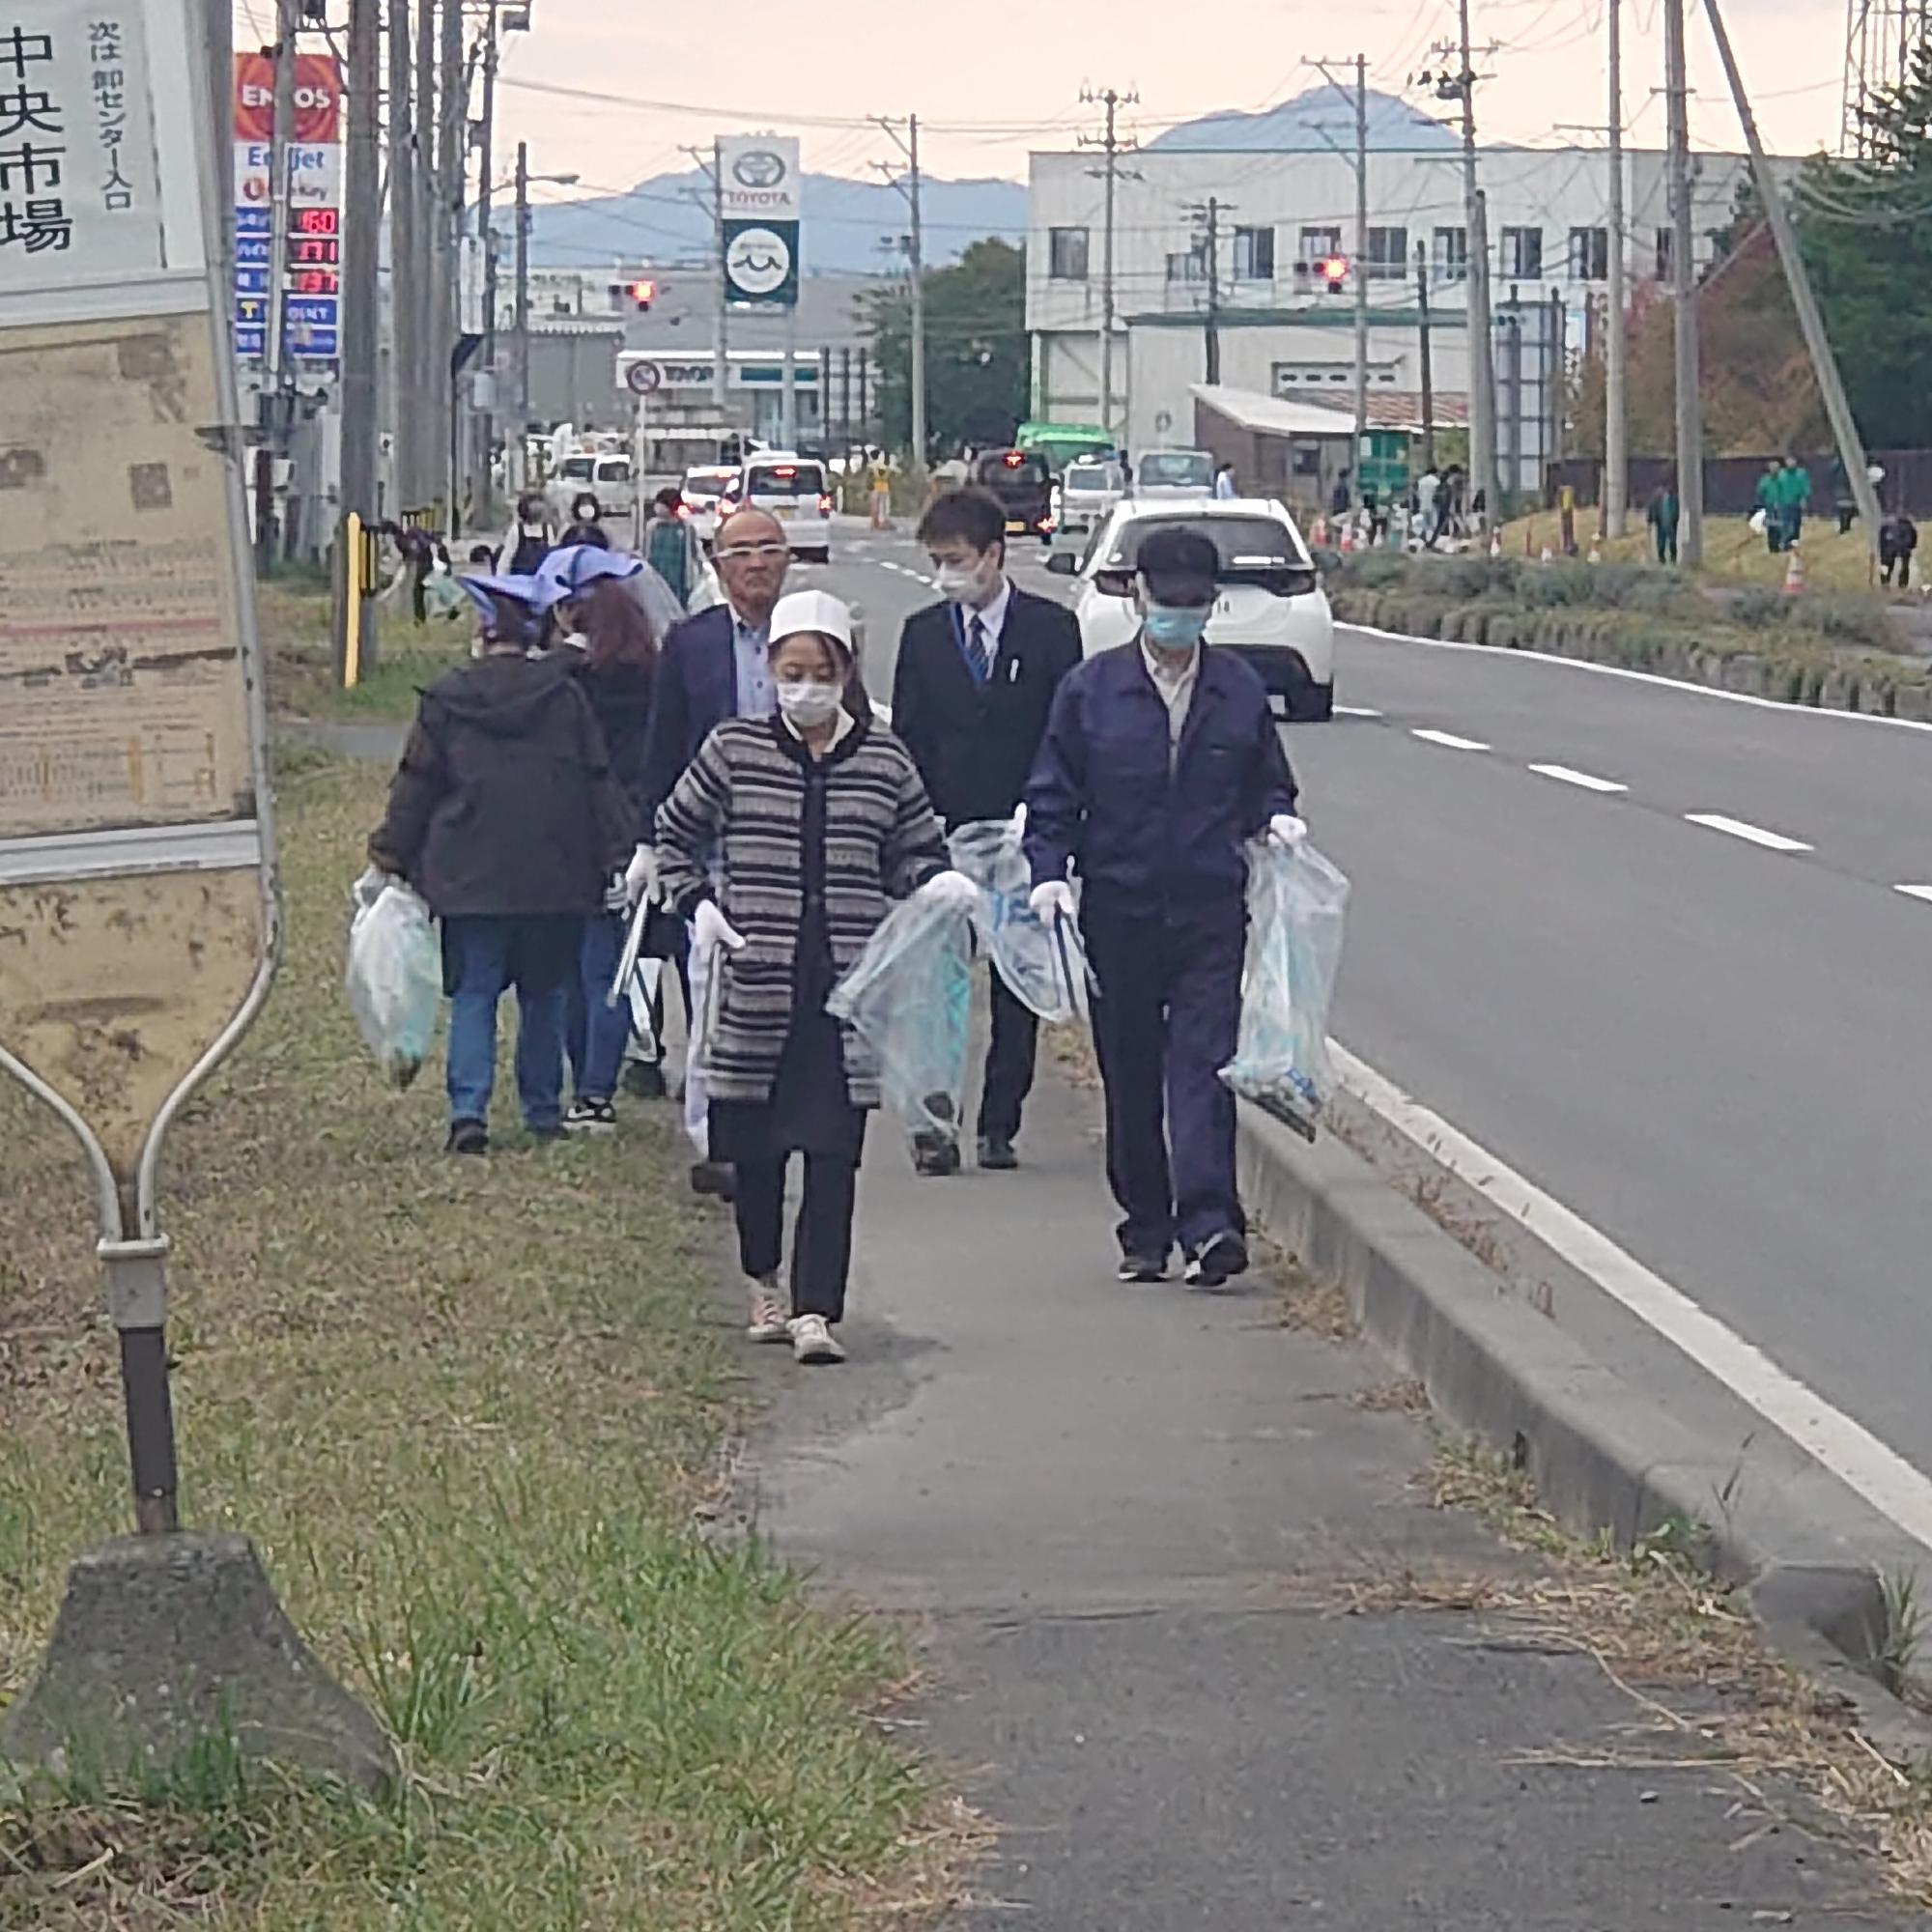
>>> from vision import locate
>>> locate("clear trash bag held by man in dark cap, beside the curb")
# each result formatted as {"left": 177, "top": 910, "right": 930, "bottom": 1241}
{"left": 1221, "top": 840, "right": 1349, "bottom": 1140}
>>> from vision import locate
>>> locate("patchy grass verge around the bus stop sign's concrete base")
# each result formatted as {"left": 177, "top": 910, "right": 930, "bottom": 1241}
{"left": 0, "top": 755, "right": 962, "bottom": 1932}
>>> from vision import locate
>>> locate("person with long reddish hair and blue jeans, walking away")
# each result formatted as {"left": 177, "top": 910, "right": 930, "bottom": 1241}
{"left": 558, "top": 576, "right": 690, "bottom": 1134}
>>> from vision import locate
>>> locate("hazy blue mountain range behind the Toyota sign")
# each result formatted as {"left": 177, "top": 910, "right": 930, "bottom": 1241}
{"left": 529, "top": 168, "right": 1026, "bottom": 274}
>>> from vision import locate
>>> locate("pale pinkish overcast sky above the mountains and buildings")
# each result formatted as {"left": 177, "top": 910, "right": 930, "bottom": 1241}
{"left": 238, "top": 0, "right": 1845, "bottom": 199}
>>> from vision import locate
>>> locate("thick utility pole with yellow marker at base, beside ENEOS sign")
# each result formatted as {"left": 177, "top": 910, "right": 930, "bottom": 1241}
{"left": 336, "top": 0, "right": 383, "bottom": 670}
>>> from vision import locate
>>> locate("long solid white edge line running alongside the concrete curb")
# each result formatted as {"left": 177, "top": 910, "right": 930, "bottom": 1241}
{"left": 1333, "top": 1043, "right": 1932, "bottom": 1549}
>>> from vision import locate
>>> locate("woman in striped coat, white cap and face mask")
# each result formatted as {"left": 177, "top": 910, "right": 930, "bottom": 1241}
{"left": 655, "top": 595, "right": 978, "bottom": 1362}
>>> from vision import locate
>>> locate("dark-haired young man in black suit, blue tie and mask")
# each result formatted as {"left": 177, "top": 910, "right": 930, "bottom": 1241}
{"left": 893, "top": 489, "right": 1080, "bottom": 1175}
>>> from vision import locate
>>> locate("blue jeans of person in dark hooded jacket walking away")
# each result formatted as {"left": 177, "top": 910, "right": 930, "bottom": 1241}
{"left": 442, "top": 914, "right": 583, "bottom": 1134}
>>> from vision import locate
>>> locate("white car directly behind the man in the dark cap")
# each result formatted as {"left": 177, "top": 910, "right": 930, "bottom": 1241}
{"left": 1047, "top": 497, "right": 1335, "bottom": 723}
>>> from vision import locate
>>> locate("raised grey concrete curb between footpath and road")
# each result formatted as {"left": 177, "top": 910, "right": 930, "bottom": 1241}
{"left": 1238, "top": 1101, "right": 1932, "bottom": 1756}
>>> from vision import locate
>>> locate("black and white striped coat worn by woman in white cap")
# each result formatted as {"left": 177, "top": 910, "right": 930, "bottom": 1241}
{"left": 655, "top": 719, "right": 949, "bottom": 1107}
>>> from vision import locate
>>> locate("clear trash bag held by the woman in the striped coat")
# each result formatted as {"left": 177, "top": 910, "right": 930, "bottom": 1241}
{"left": 825, "top": 898, "right": 972, "bottom": 1142}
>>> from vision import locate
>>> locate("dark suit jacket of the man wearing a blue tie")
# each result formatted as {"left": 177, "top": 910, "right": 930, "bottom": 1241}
{"left": 893, "top": 585, "right": 1080, "bottom": 829}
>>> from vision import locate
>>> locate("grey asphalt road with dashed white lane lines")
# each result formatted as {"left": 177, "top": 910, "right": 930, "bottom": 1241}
{"left": 827, "top": 533, "right": 1932, "bottom": 1515}
